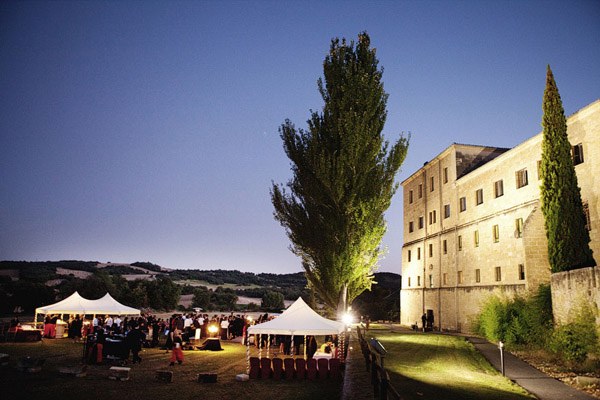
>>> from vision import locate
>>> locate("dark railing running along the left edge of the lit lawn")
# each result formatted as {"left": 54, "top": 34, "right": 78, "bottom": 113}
{"left": 356, "top": 326, "right": 402, "bottom": 400}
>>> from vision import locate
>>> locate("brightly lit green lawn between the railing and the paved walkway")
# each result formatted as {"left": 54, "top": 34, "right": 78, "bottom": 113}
{"left": 367, "top": 325, "right": 534, "bottom": 400}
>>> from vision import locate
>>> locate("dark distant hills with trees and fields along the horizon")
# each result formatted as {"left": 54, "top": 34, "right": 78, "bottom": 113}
{"left": 0, "top": 260, "right": 400, "bottom": 319}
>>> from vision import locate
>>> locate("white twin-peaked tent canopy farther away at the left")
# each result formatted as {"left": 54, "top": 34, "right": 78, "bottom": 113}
{"left": 35, "top": 292, "right": 140, "bottom": 315}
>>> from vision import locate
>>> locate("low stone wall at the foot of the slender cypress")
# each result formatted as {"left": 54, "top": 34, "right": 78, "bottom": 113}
{"left": 551, "top": 267, "right": 600, "bottom": 327}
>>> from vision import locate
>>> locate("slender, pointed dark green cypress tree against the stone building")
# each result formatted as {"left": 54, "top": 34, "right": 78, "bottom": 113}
{"left": 540, "top": 66, "right": 596, "bottom": 272}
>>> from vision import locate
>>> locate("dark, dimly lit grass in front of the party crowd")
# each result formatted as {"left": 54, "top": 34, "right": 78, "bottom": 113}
{"left": 0, "top": 339, "right": 341, "bottom": 400}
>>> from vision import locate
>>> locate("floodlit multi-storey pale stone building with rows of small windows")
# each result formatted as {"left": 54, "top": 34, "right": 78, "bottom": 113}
{"left": 400, "top": 100, "right": 600, "bottom": 331}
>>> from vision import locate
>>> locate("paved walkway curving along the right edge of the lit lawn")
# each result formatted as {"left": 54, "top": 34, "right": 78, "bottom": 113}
{"left": 467, "top": 337, "right": 597, "bottom": 400}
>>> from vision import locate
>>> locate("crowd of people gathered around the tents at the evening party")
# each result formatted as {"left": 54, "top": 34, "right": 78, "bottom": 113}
{"left": 44, "top": 312, "right": 337, "bottom": 365}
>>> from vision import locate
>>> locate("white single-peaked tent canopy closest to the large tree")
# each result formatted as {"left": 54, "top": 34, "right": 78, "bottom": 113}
{"left": 248, "top": 297, "right": 345, "bottom": 336}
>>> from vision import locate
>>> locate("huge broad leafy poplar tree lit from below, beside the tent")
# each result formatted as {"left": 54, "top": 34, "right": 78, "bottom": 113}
{"left": 271, "top": 32, "right": 408, "bottom": 313}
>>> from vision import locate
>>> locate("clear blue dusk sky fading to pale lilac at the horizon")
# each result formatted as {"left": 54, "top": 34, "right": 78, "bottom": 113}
{"left": 0, "top": 0, "right": 600, "bottom": 273}
